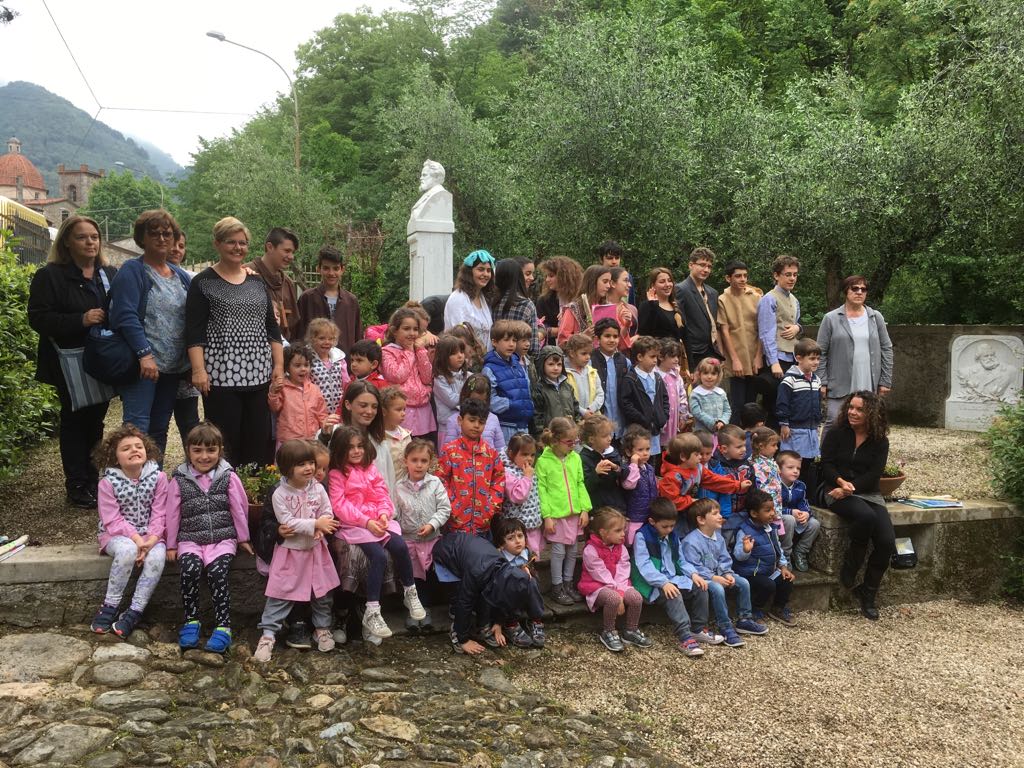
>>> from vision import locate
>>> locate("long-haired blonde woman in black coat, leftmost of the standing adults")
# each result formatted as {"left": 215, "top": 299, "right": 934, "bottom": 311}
{"left": 29, "top": 216, "right": 117, "bottom": 509}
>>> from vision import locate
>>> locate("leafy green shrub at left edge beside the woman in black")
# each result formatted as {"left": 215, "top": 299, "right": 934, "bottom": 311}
{"left": 0, "top": 232, "right": 59, "bottom": 479}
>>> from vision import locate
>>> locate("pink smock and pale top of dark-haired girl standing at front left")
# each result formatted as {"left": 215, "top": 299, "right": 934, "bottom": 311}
{"left": 264, "top": 479, "right": 341, "bottom": 602}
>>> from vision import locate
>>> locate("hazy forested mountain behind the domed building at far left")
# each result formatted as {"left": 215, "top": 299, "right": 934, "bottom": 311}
{"left": 0, "top": 81, "right": 183, "bottom": 195}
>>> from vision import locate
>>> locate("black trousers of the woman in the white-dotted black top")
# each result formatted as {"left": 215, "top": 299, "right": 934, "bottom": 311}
{"left": 203, "top": 384, "right": 272, "bottom": 467}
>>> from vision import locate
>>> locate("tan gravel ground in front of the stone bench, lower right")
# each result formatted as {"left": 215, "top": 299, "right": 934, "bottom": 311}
{"left": 510, "top": 601, "right": 1024, "bottom": 768}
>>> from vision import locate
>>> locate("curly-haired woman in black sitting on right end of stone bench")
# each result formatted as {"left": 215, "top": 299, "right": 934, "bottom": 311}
{"left": 821, "top": 391, "right": 896, "bottom": 621}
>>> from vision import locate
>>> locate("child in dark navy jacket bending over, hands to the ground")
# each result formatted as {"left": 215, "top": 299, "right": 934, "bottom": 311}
{"left": 434, "top": 532, "right": 545, "bottom": 654}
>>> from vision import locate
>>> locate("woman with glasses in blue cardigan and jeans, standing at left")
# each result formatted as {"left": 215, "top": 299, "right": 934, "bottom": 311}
{"left": 110, "top": 210, "right": 191, "bottom": 453}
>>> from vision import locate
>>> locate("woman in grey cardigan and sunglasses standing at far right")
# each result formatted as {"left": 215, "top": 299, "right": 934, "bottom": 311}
{"left": 818, "top": 274, "right": 893, "bottom": 435}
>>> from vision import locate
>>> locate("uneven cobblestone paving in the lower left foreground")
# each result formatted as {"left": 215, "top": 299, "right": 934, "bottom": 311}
{"left": 0, "top": 627, "right": 679, "bottom": 768}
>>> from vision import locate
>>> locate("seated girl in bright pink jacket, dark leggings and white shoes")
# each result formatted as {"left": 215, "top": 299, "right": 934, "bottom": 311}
{"left": 327, "top": 427, "right": 427, "bottom": 637}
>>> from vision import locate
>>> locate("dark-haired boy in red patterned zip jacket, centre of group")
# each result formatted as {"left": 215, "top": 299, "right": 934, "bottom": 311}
{"left": 437, "top": 399, "right": 505, "bottom": 540}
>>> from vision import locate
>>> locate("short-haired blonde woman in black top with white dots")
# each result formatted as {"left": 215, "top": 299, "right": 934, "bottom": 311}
{"left": 185, "top": 216, "right": 285, "bottom": 466}
